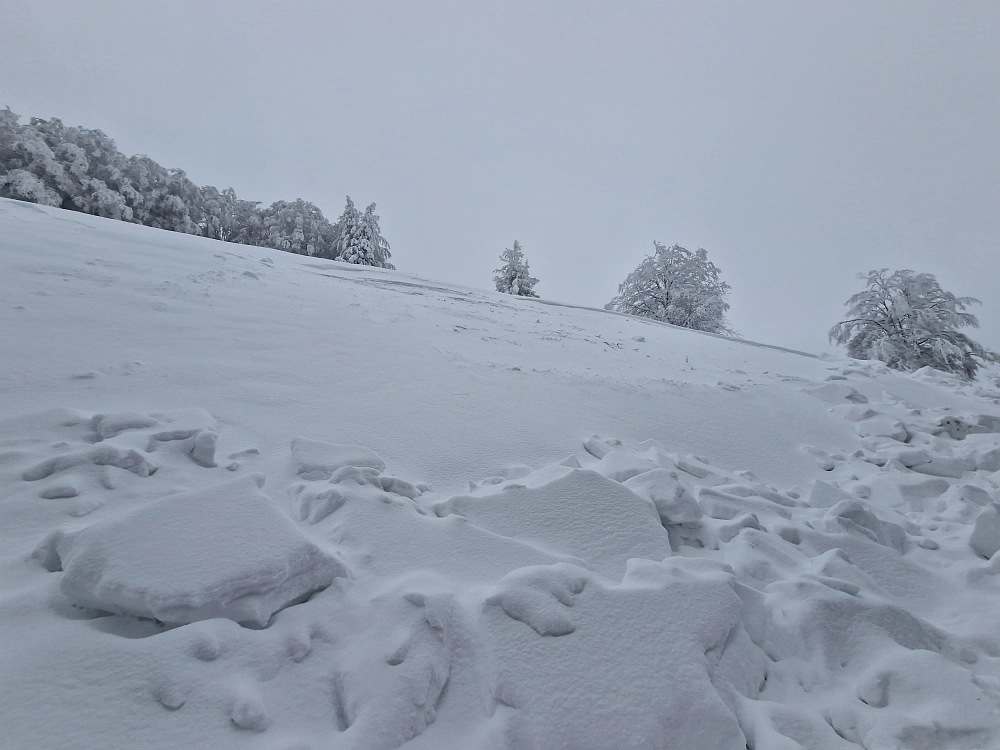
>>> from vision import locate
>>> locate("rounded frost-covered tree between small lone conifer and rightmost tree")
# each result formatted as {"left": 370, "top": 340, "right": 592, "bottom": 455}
{"left": 604, "top": 242, "right": 735, "bottom": 335}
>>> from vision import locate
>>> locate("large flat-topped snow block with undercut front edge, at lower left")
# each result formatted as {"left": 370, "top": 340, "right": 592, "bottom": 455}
{"left": 58, "top": 475, "right": 348, "bottom": 627}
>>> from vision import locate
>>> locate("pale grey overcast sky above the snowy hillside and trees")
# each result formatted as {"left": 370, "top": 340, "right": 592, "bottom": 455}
{"left": 0, "top": 0, "right": 1000, "bottom": 352}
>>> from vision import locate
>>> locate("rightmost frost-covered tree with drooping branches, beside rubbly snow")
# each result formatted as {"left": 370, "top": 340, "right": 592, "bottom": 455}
{"left": 830, "top": 268, "right": 1000, "bottom": 378}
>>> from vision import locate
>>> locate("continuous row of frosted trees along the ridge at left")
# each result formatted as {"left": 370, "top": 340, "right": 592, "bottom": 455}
{"left": 0, "top": 107, "right": 393, "bottom": 268}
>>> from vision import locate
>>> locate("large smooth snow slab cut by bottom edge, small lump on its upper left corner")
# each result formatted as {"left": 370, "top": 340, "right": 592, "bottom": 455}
{"left": 481, "top": 557, "right": 752, "bottom": 750}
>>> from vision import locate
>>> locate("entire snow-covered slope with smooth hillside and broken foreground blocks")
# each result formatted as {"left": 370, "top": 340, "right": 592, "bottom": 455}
{"left": 0, "top": 200, "right": 1000, "bottom": 750}
